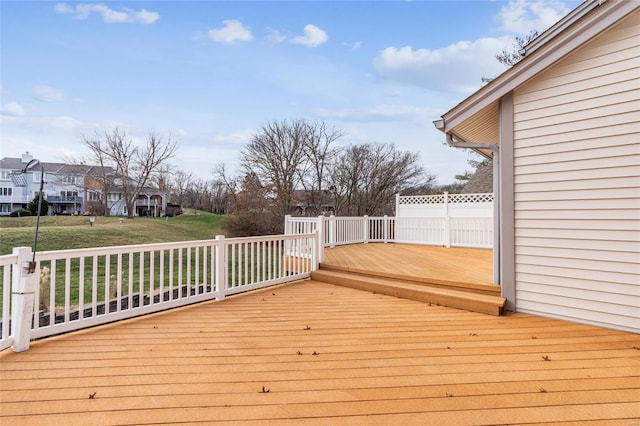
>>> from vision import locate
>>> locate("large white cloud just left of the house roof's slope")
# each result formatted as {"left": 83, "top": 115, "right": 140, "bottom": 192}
{"left": 374, "top": 37, "right": 512, "bottom": 94}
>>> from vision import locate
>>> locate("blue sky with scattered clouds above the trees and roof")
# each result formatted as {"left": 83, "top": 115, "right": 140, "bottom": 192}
{"left": 0, "top": 0, "right": 579, "bottom": 184}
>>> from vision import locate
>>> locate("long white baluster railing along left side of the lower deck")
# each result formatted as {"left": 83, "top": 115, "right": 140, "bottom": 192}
{"left": 0, "top": 232, "right": 318, "bottom": 351}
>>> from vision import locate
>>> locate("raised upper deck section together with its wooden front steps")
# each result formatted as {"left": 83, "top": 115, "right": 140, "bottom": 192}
{"left": 311, "top": 244, "right": 506, "bottom": 315}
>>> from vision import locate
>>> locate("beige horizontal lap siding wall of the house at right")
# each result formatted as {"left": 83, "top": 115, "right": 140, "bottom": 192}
{"left": 513, "top": 12, "right": 640, "bottom": 332}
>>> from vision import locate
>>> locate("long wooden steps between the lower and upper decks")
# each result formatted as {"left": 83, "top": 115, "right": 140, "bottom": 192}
{"left": 311, "top": 269, "right": 506, "bottom": 316}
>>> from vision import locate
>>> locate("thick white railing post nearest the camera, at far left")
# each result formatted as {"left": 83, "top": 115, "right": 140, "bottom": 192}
{"left": 11, "top": 247, "right": 39, "bottom": 352}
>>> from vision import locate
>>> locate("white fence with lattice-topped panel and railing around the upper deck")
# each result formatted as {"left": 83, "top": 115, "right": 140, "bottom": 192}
{"left": 285, "top": 193, "right": 493, "bottom": 260}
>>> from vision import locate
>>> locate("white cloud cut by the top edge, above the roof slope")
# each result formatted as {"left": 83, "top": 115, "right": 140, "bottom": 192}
{"left": 498, "top": 0, "right": 570, "bottom": 34}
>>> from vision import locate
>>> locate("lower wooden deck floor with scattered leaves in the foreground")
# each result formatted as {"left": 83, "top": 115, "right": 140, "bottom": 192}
{"left": 0, "top": 281, "right": 640, "bottom": 426}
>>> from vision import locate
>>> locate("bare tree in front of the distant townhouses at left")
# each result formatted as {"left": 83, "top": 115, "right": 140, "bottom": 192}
{"left": 82, "top": 128, "right": 177, "bottom": 218}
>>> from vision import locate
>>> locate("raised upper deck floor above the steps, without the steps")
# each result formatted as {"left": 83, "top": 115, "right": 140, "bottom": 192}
{"left": 324, "top": 243, "right": 493, "bottom": 285}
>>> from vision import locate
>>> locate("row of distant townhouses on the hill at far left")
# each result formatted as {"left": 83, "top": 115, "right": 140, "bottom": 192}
{"left": 0, "top": 152, "right": 167, "bottom": 216}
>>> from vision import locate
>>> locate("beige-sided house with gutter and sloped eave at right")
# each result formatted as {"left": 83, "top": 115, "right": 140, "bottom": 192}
{"left": 435, "top": 0, "right": 640, "bottom": 333}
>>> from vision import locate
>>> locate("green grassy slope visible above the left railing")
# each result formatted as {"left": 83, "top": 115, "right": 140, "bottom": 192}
{"left": 0, "top": 212, "right": 224, "bottom": 255}
